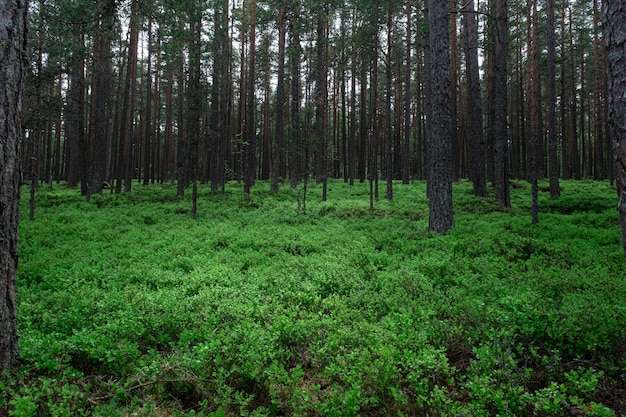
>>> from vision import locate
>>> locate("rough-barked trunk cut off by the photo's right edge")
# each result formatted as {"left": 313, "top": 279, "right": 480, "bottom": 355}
{"left": 603, "top": 0, "right": 626, "bottom": 260}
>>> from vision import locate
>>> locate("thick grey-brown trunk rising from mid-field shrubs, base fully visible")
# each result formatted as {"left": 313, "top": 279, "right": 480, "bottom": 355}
{"left": 428, "top": 0, "right": 454, "bottom": 234}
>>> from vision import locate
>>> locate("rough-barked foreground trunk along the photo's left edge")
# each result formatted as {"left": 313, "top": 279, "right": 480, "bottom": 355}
{"left": 0, "top": 0, "right": 28, "bottom": 372}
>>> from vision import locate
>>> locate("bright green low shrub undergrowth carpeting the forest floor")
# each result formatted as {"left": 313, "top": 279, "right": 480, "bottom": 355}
{"left": 0, "top": 181, "right": 626, "bottom": 416}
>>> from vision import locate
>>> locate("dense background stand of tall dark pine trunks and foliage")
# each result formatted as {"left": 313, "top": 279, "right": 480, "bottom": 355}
{"left": 23, "top": 0, "right": 613, "bottom": 205}
